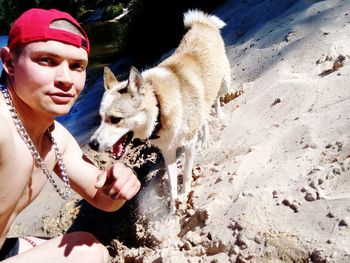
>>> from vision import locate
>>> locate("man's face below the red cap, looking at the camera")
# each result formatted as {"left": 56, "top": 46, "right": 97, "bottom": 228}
{"left": 12, "top": 41, "right": 88, "bottom": 116}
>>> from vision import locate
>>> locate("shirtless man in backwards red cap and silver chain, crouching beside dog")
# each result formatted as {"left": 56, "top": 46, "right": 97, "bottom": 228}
{"left": 0, "top": 9, "right": 140, "bottom": 263}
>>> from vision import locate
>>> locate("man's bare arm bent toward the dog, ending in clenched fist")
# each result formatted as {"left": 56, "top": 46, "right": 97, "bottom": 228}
{"left": 53, "top": 123, "right": 140, "bottom": 211}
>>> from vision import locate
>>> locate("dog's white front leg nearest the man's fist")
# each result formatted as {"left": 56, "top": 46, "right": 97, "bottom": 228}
{"left": 163, "top": 150, "right": 178, "bottom": 213}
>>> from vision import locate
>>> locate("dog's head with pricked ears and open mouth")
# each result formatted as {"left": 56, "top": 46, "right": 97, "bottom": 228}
{"left": 89, "top": 67, "right": 146, "bottom": 158}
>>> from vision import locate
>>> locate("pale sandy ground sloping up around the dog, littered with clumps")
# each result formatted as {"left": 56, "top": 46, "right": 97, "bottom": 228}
{"left": 8, "top": 0, "right": 350, "bottom": 263}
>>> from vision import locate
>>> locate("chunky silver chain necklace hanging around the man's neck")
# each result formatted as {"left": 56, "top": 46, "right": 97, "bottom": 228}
{"left": 1, "top": 86, "right": 72, "bottom": 200}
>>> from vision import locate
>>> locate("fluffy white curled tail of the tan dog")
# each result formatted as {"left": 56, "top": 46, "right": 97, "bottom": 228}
{"left": 184, "top": 10, "right": 226, "bottom": 29}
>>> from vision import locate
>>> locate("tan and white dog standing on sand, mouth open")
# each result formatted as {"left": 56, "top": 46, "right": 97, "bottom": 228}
{"left": 89, "top": 10, "right": 231, "bottom": 212}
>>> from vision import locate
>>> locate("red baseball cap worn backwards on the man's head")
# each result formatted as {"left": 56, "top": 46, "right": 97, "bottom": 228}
{"left": 8, "top": 8, "right": 90, "bottom": 53}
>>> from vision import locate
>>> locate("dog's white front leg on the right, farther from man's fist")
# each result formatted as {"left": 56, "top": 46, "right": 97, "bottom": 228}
{"left": 182, "top": 137, "right": 197, "bottom": 197}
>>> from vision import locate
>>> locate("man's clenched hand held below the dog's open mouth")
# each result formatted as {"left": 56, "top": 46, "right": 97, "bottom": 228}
{"left": 95, "top": 163, "right": 141, "bottom": 201}
